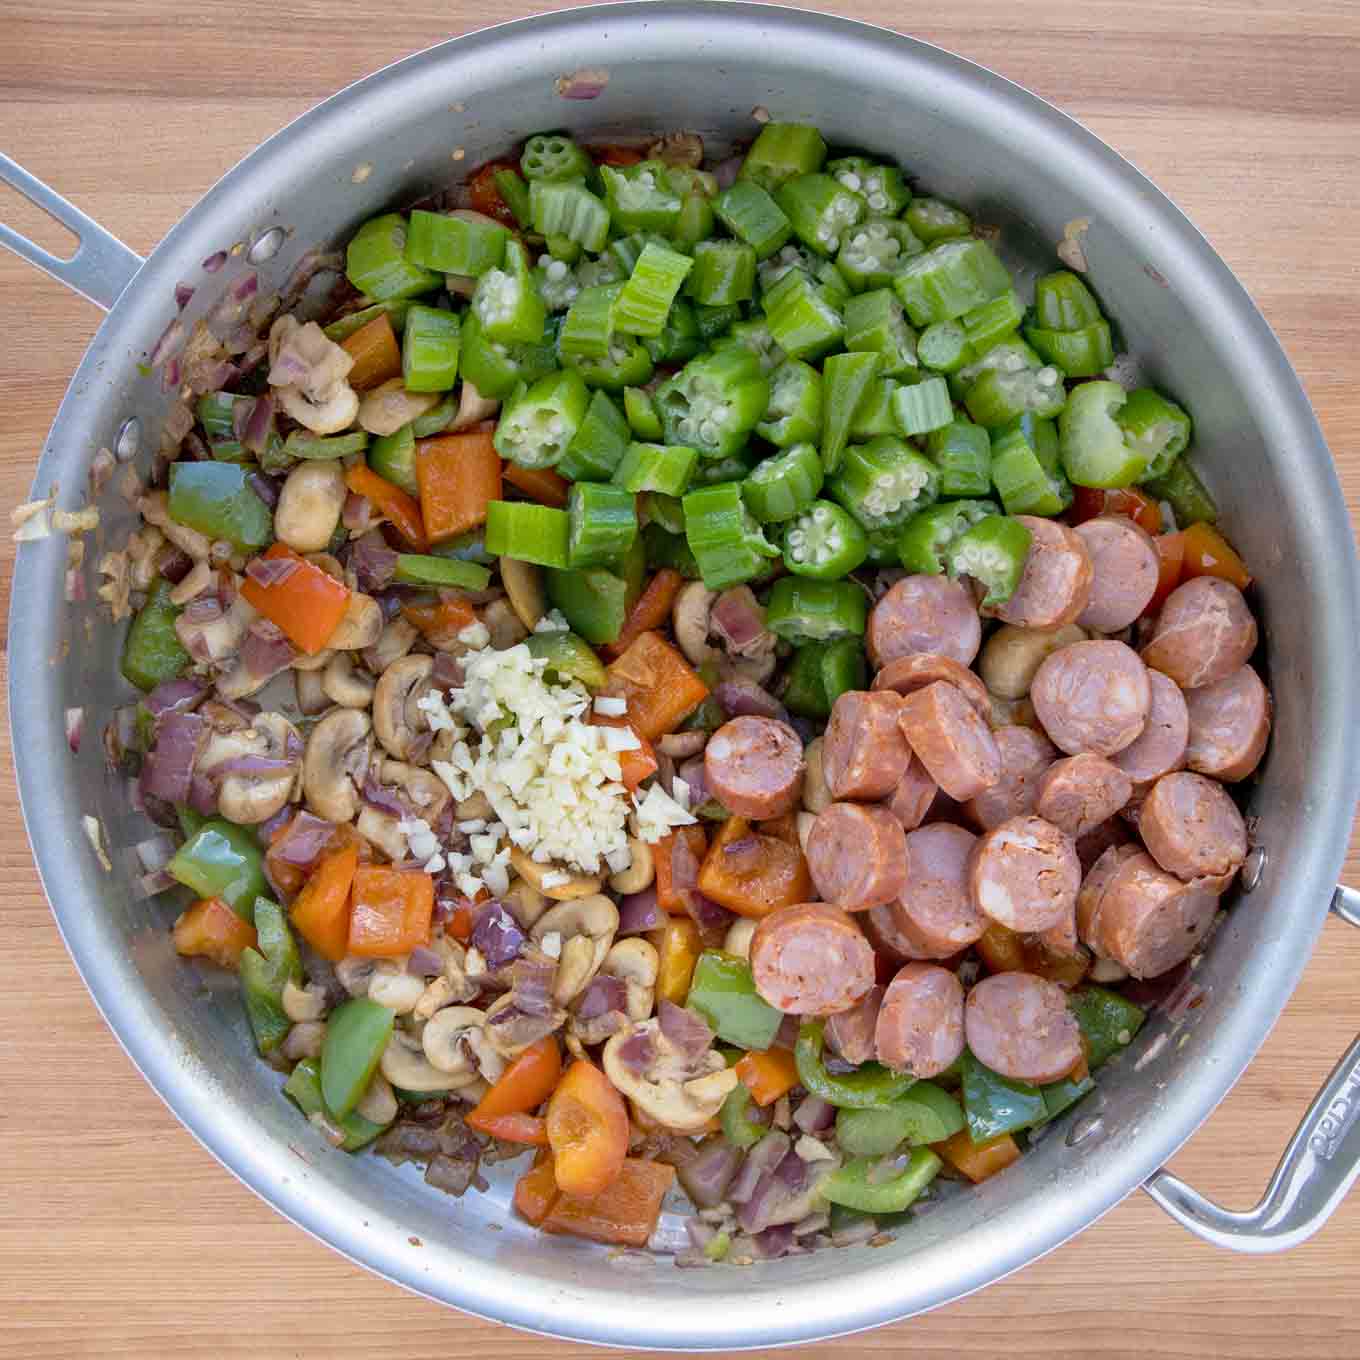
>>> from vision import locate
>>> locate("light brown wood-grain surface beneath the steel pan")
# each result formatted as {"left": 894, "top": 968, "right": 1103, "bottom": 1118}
{"left": 0, "top": 0, "right": 1360, "bottom": 1360}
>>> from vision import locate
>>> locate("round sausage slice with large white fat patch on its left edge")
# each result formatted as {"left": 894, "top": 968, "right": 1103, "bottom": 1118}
{"left": 971, "top": 817, "right": 1081, "bottom": 930}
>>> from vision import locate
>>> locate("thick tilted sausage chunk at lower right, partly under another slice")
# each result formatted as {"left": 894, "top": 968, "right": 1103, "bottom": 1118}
{"left": 1087, "top": 847, "right": 1228, "bottom": 978}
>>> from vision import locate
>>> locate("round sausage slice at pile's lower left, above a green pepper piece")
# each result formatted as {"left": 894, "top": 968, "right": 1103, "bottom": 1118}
{"left": 751, "top": 902, "right": 874, "bottom": 1016}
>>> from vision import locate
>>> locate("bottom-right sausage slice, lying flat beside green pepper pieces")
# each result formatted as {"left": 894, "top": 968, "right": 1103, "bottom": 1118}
{"left": 963, "top": 972, "right": 1081, "bottom": 1085}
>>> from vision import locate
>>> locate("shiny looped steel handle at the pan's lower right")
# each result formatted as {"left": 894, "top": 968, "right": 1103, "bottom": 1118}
{"left": 1142, "top": 887, "right": 1360, "bottom": 1253}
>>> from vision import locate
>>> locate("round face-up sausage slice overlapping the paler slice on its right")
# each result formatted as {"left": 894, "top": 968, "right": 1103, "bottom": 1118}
{"left": 1030, "top": 639, "right": 1152, "bottom": 756}
